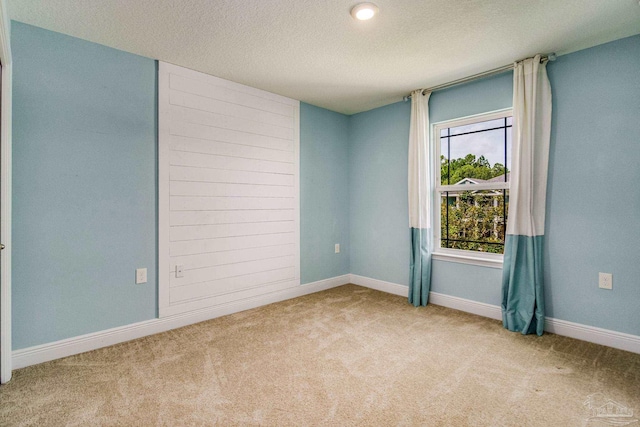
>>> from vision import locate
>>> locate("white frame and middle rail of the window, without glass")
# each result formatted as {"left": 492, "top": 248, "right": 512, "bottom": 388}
{"left": 431, "top": 108, "right": 513, "bottom": 268}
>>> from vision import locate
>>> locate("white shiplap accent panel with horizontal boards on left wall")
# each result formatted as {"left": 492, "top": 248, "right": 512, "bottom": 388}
{"left": 158, "top": 62, "right": 300, "bottom": 317}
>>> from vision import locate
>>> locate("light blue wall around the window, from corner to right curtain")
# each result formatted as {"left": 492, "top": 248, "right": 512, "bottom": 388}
{"left": 349, "top": 74, "right": 513, "bottom": 304}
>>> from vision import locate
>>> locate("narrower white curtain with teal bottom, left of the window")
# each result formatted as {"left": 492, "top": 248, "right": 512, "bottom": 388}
{"left": 409, "top": 90, "right": 433, "bottom": 307}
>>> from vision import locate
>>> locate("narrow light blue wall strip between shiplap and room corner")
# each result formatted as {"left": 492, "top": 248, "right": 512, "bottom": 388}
{"left": 300, "top": 103, "right": 351, "bottom": 283}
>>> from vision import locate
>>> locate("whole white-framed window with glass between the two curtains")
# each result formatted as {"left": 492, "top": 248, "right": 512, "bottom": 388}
{"left": 433, "top": 110, "right": 512, "bottom": 262}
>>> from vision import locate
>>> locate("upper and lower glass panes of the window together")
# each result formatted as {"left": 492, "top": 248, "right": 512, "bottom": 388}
{"left": 439, "top": 113, "right": 512, "bottom": 253}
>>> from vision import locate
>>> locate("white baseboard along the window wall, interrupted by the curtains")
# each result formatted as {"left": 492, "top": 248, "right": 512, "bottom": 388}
{"left": 351, "top": 274, "right": 640, "bottom": 354}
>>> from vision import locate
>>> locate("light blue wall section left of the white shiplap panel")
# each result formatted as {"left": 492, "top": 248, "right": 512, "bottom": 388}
{"left": 11, "top": 22, "right": 157, "bottom": 349}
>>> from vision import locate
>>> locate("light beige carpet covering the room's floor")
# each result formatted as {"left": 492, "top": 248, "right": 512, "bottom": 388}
{"left": 0, "top": 285, "right": 640, "bottom": 426}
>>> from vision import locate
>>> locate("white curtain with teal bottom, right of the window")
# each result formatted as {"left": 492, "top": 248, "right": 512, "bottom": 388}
{"left": 502, "top": 55, "right": 551, "bottom": 335}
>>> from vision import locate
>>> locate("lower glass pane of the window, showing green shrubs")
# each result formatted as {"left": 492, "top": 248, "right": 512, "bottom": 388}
{"left": 440, "top": 190, "right": 509, "bottom": 254}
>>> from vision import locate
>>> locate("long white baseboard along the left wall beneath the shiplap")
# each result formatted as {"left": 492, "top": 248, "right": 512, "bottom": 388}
{"left": 12, "top": 274, "right": 350, "bottom": 369}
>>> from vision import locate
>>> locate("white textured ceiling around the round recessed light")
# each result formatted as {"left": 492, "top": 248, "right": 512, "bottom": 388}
{"left": 8, "top": 0, "right": 640, "bottom": 114}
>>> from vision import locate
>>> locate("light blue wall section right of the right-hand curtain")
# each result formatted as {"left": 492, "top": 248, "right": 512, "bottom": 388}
{"left": 545, "top": 36, "right": 640, "bottom": 335}
